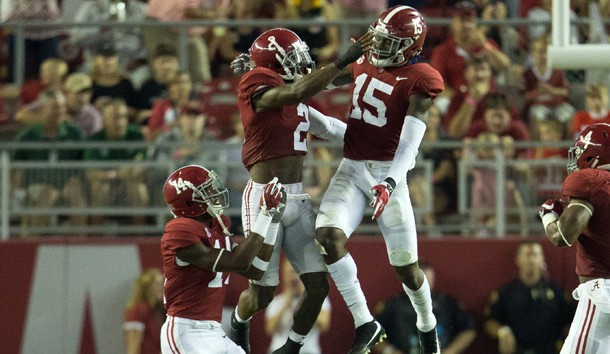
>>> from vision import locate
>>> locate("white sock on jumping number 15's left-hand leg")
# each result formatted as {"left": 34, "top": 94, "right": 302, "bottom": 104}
{"left": 327, "top": 253, "right": 373, "bottom": 327}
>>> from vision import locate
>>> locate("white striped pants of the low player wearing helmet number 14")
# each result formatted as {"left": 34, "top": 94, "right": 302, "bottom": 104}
{"left": 161, "top": 316, "right": 245, "bottom": 354}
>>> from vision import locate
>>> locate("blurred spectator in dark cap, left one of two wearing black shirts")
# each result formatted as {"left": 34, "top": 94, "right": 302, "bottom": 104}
{"left": 90, "top": 41, "right": 137, "bottom": 117}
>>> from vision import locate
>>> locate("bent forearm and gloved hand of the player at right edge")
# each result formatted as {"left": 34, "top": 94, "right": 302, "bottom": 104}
{"left": 538, "top": 199, "right": 594, "bottom": 247}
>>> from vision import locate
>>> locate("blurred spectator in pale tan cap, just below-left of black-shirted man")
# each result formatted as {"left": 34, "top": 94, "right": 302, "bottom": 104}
{"left": 64, "top": 73, "right": 104, "bottom": 138}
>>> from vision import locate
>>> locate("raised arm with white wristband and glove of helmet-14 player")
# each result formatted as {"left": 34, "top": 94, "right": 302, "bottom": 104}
{"left": 176, "top": 178, "right": 286, "bottom": 272}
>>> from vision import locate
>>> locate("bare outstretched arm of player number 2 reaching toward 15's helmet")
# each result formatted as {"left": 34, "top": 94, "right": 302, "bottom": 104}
{"left": 253, "top": 32, "right": 373, "bottom": 112}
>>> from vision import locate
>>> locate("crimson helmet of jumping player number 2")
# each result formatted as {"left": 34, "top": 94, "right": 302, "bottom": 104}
{"left": 249, "top": 28, "right": 315, "bottom": 81}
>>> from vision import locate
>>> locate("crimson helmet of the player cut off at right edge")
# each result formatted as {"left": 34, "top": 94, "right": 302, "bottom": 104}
{"left": 568, "top": 123, "right": 610, "bottom": 173}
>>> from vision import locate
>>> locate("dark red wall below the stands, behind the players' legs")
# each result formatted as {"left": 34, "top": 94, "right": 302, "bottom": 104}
{"left": 0, "top": 236, "right": 577, "bottom": 354}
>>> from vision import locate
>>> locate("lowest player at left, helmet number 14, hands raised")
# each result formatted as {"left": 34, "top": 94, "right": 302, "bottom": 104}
{"left": 161, "top": 165, "right": 286, "bottom": 354}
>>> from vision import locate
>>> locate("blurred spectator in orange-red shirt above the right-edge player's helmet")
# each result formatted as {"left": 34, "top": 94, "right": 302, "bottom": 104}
{"left": 572, "top": 84, "right": 610, "bottom": 136}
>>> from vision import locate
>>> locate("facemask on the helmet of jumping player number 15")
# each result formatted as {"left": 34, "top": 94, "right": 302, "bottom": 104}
{"left": 368, "top": 24, "right": 415, "bottom": 68}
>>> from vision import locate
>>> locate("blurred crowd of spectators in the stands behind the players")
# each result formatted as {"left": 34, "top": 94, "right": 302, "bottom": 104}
{"left": 0, "top": 0, "right": 610, "bottom": 236}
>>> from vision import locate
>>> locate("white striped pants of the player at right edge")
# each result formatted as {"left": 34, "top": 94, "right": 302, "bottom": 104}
{"left": 561, "top": 279, "right": 610, "bottom": 354}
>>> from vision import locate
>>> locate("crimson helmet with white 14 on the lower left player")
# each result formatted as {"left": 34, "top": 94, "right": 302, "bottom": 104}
{"left": 163, "top": 165, "right": 229, "bottom": 219}
